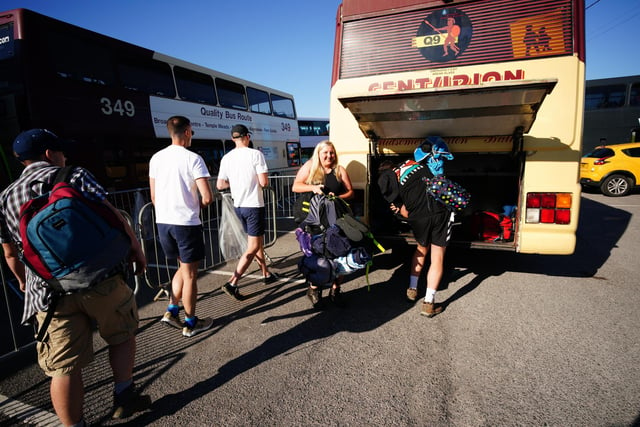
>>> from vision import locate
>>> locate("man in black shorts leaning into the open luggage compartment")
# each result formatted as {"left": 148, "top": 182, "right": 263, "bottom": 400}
{"left": 381, "top": 137, "right": 453, "bottom": 317}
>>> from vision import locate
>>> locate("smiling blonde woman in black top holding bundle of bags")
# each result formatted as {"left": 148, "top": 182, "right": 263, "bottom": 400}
{"left": 292, "top": 141, "right": 353, "bottom": 308}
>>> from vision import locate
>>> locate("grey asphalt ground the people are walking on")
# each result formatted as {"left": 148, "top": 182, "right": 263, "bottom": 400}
{"left": 0, "top": 194, "right": 640, "bottom": 426}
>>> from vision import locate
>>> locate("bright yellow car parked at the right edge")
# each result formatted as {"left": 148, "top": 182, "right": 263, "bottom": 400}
{"left": 580, "top": 142, "right": 640, "bottom": 197}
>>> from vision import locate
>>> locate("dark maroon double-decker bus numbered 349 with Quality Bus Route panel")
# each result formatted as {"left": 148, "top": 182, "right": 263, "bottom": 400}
{"left": 0, "top": 9, "right": 300, "bottom": 190}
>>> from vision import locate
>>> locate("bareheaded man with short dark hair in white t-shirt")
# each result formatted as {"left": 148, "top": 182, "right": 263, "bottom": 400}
{"left": 149, "top": 116, "right": 213, "bottom": 337}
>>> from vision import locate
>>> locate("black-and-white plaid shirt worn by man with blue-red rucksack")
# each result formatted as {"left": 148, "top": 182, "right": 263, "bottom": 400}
{"left": 0, "top": 161, "right": 107, "bottom": 324}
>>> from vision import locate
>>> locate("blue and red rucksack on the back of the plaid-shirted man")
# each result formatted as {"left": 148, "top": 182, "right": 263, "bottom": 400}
{"left": 20, "top": 167, "right": 131, "bottom": 292}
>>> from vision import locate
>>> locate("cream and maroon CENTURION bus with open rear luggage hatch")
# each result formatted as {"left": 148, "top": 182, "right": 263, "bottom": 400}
{"left": 329, "top": 0, "right": 585, "bottom": 254}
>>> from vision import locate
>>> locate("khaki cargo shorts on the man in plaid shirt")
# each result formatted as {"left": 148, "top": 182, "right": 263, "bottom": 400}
{"left": 37, "top": 275, "right": 138, "bottom": 377}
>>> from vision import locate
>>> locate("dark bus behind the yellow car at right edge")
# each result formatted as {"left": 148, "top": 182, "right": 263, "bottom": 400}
{"left": 583, "top": 75, "right": 640, "bottom": 153}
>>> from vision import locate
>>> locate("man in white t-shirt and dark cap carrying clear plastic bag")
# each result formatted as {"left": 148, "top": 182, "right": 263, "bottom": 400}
{"left": 216, "top": 125, "right": 278, "bottom": 300}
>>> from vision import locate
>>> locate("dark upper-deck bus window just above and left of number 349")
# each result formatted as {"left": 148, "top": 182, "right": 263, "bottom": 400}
{"left": 47, "top": 32, "right": 115, "bottom": 85}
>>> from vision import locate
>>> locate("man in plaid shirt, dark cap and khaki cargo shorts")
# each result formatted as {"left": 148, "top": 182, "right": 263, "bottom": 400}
{"left": 0, "top": 129, "right": 151, "bottom": 426}
